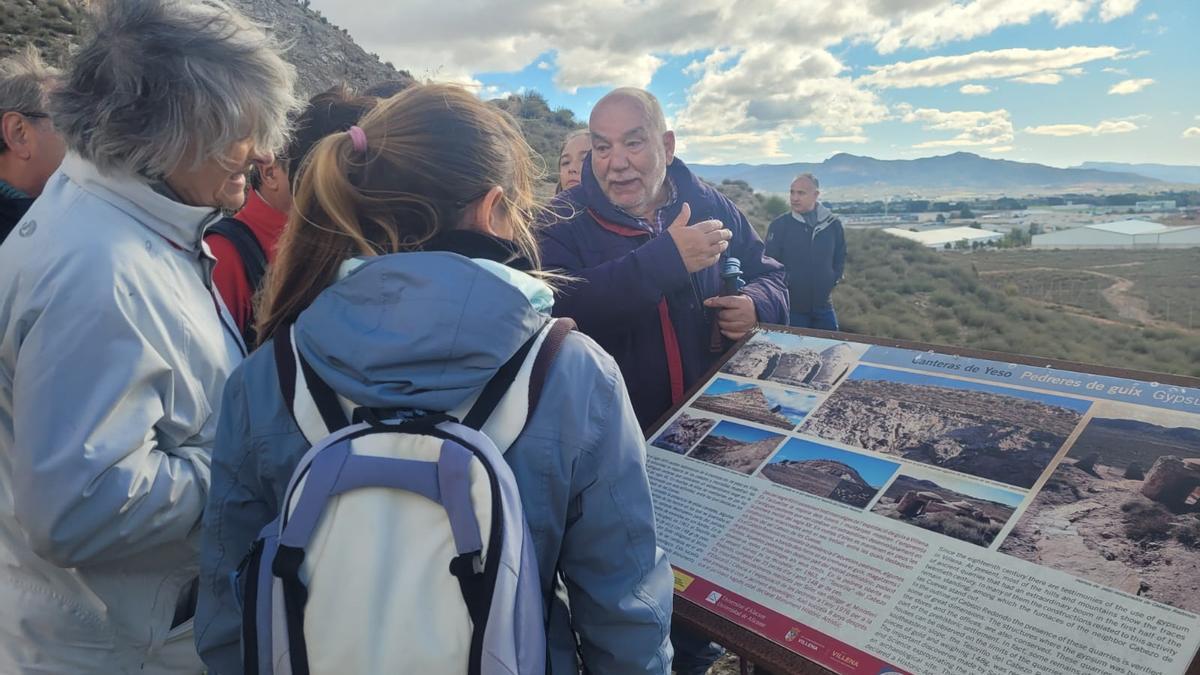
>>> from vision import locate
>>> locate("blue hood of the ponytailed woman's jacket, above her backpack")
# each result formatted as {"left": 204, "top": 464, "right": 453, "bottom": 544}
{"left": 295, "top": 251, "right": 551, "bottom": 412}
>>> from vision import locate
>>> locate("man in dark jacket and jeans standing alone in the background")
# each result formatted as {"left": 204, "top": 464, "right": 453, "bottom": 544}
{"left": 766, "top": 173, "right": 846, "bottom": 330}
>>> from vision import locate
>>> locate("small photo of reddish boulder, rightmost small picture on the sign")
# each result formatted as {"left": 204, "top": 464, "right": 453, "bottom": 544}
{"left": 871, "top": 476, "right": 1019, "bottom": 548}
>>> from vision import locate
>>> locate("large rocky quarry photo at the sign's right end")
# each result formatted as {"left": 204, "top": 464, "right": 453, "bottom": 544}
{"left": 1000, "top": 402, "right": 1200, "bottom": 613}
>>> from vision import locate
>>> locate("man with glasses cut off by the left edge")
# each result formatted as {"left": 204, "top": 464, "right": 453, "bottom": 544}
{"left": 0, "top": 47, "right": 66, "bottom": 241}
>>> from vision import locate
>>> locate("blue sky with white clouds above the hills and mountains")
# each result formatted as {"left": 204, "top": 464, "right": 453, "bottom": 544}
{"left": 312, "top": 0, "right": 1200, "bottom": 166}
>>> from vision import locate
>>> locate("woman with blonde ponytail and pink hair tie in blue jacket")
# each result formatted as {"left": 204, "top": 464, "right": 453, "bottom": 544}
{"left": 197, "top": 84, "right": 672, "bottom": 675}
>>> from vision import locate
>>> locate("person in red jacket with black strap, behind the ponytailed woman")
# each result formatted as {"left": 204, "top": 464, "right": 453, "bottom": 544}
{"left": 204, "top": 86, "right": 378, "bottom": 348}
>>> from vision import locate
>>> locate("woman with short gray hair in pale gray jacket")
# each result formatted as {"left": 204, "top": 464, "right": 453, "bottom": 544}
{"left": 0, "top": 0, "right": 299, "bottom": 675}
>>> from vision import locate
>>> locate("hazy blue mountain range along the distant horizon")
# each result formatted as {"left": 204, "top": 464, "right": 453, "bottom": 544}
{"left": 689, "top": 153, "right": 1176, "bottom": 192}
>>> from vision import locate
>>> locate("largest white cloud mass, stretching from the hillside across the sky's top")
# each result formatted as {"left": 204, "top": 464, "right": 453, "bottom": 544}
{"left": 295, "top": 0, "right": 1138, "bottom": 157}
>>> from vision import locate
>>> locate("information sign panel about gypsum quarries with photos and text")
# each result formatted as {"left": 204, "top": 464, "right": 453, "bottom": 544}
{"left": 647, "top": 328, "right": 1200, "bottom": 675}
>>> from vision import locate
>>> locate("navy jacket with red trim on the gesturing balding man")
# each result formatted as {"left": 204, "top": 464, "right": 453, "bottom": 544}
{"left": 540, "top": 159, "right": 787, "bottom": 429}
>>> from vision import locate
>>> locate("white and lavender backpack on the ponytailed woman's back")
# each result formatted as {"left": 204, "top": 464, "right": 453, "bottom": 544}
{"left": 235, "top": 319, "right": 574, "bottom": 675}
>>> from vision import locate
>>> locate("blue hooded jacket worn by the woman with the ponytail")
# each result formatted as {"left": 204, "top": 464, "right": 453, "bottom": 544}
{"left": 196, "top": 252, "right": 672, "bottom": 675}
